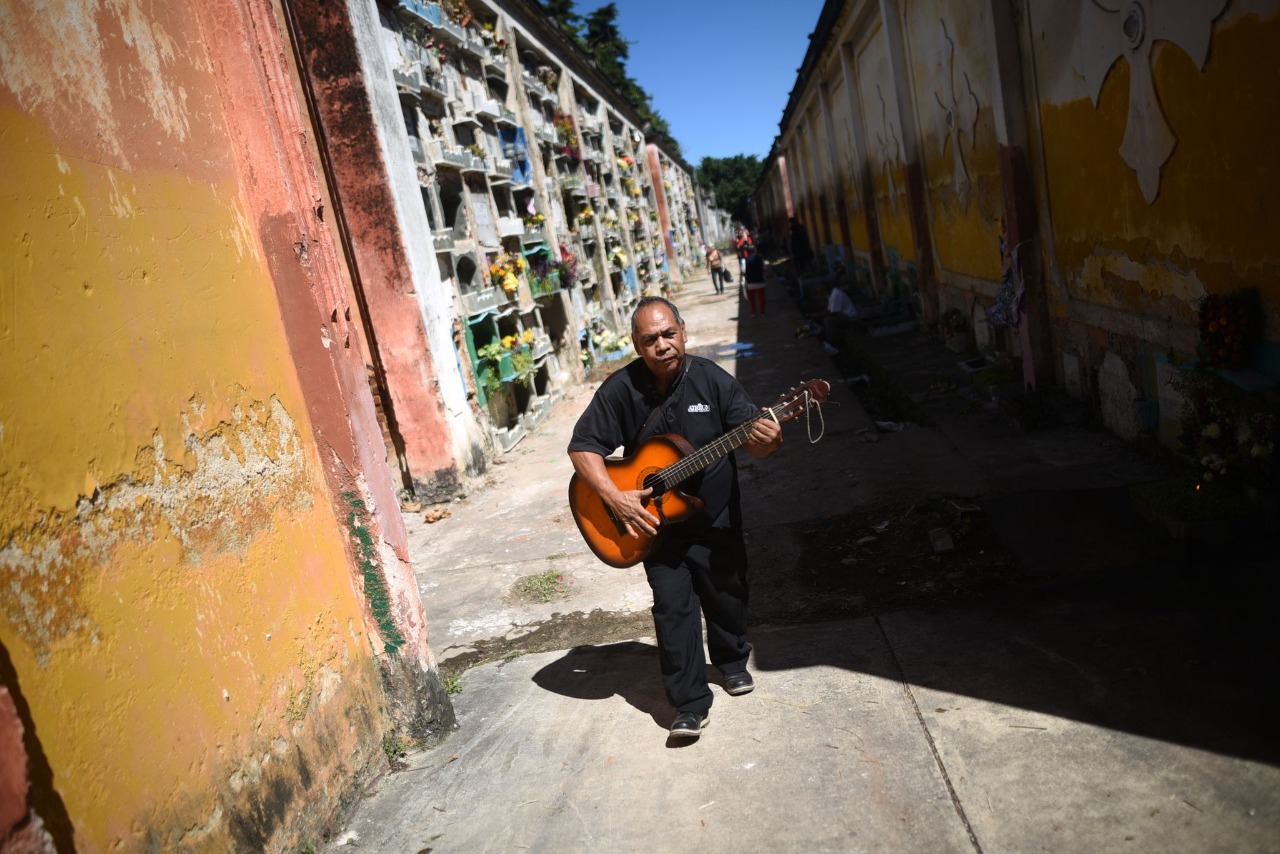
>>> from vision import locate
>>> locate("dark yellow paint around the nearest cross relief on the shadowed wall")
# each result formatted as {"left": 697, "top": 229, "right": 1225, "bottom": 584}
{"left": 1039, "top": 10, "right": 1280, "bottom": 323}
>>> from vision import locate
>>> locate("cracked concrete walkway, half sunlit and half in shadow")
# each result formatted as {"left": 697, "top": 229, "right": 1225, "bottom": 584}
{"left": 330, "top": 272, "right": 1280, "bottom": 851}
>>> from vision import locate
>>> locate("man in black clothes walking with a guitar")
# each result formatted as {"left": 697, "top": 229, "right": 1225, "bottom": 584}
{"left": 568, "top": 297, "right": 782, "bottom": 739}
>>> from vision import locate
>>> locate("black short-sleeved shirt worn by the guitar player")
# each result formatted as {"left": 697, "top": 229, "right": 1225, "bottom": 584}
{"left": 568, "top": 353, "right": 760, "bottom": 528}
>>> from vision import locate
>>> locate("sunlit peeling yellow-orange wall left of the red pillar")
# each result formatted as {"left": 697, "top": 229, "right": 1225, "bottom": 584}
{"left": 0, "top": 3, "right": 381, "bottom": 851}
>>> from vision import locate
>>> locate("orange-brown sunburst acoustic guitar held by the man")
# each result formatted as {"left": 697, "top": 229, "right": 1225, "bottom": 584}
{"left": 568, "top": 379, "right": 831, "bottom": 568}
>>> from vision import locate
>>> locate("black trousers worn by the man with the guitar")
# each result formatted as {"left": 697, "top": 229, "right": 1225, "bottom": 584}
{"left": 645, "top": 528, "right": 751, "bottom": 714}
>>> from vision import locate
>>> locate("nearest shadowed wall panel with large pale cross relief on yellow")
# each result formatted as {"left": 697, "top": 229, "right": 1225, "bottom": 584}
{"left": 1028, "top": 0, "right": 1280, "bottom": 327}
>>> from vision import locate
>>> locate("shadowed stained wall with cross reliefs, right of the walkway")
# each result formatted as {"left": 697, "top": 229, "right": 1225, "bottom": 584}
{"left": 762, "top": 0, "right": 1280, "bottom": 437}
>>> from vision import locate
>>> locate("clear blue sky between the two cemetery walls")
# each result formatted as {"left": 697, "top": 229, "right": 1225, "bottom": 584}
{"left": 575, "top": 0, "right": 823, "bottom": 166}
